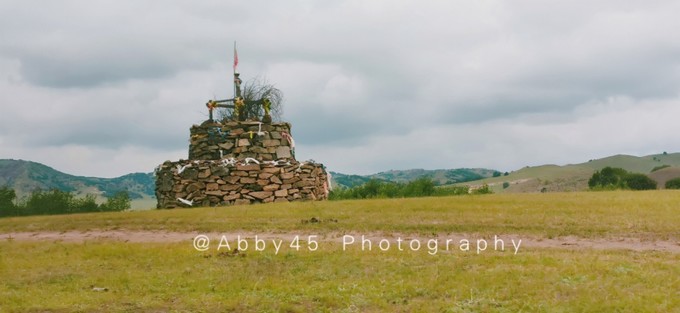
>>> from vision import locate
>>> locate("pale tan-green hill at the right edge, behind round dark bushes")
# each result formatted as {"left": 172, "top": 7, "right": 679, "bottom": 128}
{"left": 456, "top": 153, "right": 680, "bottom": 193}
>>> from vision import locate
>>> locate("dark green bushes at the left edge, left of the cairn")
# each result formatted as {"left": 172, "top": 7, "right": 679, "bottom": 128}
{"left": 0, "top": 186, "right": 130, "bottom": 216}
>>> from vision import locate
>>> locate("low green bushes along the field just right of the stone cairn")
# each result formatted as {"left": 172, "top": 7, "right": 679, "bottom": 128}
{"left": 329, "top": 177, "right": 491, "bottom": 200}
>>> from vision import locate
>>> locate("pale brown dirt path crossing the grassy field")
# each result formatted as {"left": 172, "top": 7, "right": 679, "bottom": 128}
{"left": 0, "top": 230, "right": 680, "bottom": 253}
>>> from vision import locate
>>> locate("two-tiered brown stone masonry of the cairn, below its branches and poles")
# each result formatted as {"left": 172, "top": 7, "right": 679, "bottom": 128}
{"left": 156, "top": 120, "right": 330, "bottom": 208}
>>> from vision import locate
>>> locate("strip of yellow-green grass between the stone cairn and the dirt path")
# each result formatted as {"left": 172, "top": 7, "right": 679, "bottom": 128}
{"left": 0, "top": 190, "right": 680, "bottom": 240}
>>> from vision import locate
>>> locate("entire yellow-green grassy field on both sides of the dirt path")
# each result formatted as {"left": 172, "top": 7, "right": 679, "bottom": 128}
{"left": 0, "top": 191, "right": 680, "bottom": 312}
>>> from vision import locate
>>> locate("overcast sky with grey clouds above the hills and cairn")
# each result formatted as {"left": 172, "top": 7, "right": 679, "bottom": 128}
{"left": 0, "top": 0, "right": 680, "bottom": 177}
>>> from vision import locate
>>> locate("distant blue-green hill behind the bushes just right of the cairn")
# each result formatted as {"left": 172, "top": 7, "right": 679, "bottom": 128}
{"left": 331, "top": 168, "right": 500, "bottom": 187}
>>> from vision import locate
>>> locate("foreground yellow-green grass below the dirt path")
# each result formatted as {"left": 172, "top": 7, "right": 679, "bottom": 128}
{"left": 0, "top": 242, "right": 680, "bottom": 312}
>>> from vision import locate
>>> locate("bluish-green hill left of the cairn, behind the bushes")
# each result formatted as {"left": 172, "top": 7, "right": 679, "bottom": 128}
{"left": 0, "top": 159, "right": 155, "bottom": 200}
